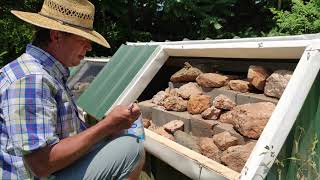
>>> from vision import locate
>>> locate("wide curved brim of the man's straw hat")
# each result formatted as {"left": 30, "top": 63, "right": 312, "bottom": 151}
{"left": 11, "top": 10, "right": 110, "bottom": 48}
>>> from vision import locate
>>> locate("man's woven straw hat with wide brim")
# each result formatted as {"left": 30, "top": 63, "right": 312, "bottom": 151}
{"left": 11, "top": 0, "right": 110, "bottom": 48}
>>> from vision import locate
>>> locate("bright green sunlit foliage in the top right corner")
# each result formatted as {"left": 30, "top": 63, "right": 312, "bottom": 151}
{"left": 269, "top": 0, "right": 320, "bottom": 35}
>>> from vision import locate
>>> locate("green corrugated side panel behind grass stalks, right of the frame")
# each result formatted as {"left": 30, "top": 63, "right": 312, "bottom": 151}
{"left": 266, "top": 74, "right": 320, "bottom": 180}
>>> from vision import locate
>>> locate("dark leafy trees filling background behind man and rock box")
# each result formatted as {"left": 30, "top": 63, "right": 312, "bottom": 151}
{"left": 0, "top": 0, "right": 320, "bottom": 66}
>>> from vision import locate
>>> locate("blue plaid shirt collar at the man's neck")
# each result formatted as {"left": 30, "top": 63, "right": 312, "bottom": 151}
{"left": 26, "top": 44, "right": 70, "bottom": 82}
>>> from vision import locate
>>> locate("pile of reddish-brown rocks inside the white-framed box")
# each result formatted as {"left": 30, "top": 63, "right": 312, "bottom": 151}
{"left": 144, "top": 63, "right": 292, "bottom": 172}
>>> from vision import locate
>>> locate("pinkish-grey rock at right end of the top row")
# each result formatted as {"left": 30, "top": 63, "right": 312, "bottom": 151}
{"left": 264, "top": 70, "right": 292, "bottom": 98}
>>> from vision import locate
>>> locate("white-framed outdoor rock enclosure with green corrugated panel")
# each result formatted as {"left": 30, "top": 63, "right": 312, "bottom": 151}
{"left": 77, "top": 36, "right": 320, "bottom": 180}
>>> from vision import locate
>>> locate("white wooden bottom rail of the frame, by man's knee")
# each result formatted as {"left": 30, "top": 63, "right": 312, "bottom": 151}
{"left": 144, "top": 129, "right": 240, "bottom": 180}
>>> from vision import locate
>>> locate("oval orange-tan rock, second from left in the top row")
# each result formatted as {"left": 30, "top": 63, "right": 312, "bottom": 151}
{"left": 196, "top": 73, "right": 229, "bottom": 88}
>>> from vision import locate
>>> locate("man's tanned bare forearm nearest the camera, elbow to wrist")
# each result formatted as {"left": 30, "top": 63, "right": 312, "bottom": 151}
{"left": 24, "top": 119, "right": 113, "bottom": 177}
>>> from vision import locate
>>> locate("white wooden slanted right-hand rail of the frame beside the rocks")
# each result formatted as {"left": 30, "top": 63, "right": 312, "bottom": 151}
{"left": 241, "top": 42, "right": 320, "bottom": 180}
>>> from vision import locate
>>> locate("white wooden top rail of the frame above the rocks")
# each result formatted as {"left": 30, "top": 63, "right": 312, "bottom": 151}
{"left": 163, "top": 40, "right": 311, "bottom": 60}
